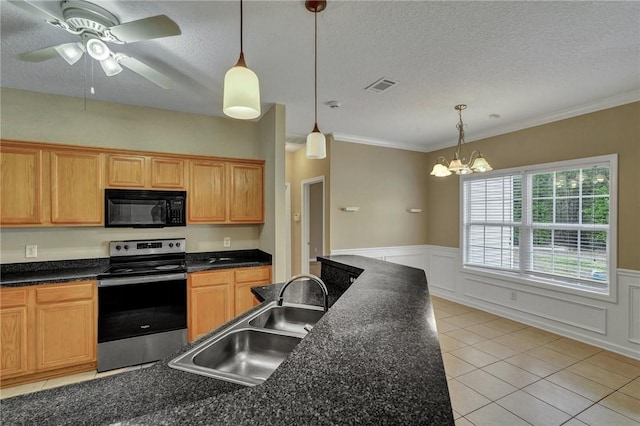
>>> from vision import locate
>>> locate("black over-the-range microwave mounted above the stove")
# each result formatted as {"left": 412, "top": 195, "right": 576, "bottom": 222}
{"left": 104, "top": 189, "right": 187, "bottom": 228}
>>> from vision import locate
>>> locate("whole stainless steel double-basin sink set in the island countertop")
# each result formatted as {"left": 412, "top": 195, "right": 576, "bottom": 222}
{"left": 169, "top": 302, "right": 325, "bottom": 386}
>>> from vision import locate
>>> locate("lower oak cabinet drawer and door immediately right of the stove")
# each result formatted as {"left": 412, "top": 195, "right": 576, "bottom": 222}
{"left": 187, "top": 271, "right": 233, "bottom": 341}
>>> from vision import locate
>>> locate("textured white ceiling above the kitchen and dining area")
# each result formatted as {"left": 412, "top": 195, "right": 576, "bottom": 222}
{"left": 0, "top": 0, "right": 640, "bottom": 151}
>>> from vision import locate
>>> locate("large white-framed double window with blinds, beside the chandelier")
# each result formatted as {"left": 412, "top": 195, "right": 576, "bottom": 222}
{"left": 462, "top": 155, "right": 617, "bottom": 294}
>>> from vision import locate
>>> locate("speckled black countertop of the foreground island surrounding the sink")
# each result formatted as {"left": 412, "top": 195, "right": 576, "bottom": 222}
{"left": 0, "top": 256, "right": 454, "bottom": 425}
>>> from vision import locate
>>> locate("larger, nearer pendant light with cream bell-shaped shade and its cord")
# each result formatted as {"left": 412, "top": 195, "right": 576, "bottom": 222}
{"left": 222, "top": 0, "right": 260, "bottom": 120}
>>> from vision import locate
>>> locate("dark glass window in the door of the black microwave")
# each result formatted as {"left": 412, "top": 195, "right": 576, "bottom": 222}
{"left": 107, "top": 199, "right": 167, "bottom": 226}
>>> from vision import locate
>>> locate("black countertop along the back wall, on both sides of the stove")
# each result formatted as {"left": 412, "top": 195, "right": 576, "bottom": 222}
{"left": 0, "top": 250, "right": 271, "bottom": 287}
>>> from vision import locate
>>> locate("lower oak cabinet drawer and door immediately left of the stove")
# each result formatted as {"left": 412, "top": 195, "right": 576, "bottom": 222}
{"left": 35, "top": 281, "right": 97, "bottom": 370}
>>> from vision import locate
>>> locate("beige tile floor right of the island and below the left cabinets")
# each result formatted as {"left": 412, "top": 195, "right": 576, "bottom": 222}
{"left": 0, "top": 297, "right": 640, "bottom": 426}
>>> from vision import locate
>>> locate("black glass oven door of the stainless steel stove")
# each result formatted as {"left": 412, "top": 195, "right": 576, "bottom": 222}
{"left": 98, "top": 273, "right": 187, "bottom": 343}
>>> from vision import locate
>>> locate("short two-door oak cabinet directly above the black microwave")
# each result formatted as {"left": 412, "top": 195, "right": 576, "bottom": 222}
{"left": 107, "top": 154, "right": 185, "bottom": 189}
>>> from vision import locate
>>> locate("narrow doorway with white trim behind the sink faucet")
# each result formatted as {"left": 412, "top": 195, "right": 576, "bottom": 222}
{"left": 301, "top": 176, "right": 325, "bottom": 275}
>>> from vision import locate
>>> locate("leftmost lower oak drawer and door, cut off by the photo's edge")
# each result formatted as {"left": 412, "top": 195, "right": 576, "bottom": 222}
{"left": 0, "top": 289, "right": 27, "bottom": 378}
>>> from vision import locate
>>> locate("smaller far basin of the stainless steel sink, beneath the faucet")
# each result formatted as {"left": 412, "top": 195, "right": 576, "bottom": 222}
{"left": 249, "top": 305, "right": 324, "bottom": 334}
